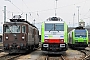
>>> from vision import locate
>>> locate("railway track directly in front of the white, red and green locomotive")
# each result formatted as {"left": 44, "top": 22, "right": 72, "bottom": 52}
{"left": 36, "top": 53, "right": 68, "bottom": 60}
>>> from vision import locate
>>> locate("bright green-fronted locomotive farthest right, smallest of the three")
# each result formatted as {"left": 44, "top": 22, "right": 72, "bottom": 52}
{"left": 68, "top": 27, "right": 88, "bottom": 47}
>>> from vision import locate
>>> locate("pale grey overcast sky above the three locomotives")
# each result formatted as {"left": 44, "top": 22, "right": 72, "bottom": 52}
{"left": 0, "top": 0, "right": 90, "bottom": 25}
